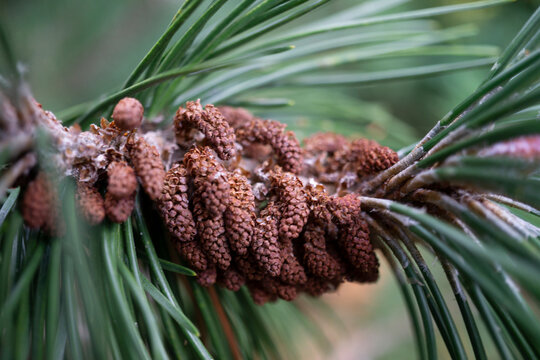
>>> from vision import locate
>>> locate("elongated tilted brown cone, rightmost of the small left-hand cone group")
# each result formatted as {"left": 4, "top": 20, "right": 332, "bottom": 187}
{"left": 127, "top": 137, "right": 165, "bottom": 201}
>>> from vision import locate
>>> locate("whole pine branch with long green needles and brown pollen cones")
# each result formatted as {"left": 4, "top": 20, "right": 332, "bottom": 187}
{"left": 0, "top": 0, "right": 540, "bottom": 359}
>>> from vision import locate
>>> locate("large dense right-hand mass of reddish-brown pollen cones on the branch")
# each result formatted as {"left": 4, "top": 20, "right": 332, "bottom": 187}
{"left": 158, "top": 101, "right": 397, "bottom": 304}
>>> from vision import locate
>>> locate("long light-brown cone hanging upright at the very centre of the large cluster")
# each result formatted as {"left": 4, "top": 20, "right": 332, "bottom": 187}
{"left": 225, "top": 172, "right": 256, "bottom": 256}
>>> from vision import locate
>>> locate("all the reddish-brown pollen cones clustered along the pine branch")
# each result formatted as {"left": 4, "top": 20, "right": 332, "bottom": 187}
{"left": 23, "top": 99, "right": 397, "bottom": 304}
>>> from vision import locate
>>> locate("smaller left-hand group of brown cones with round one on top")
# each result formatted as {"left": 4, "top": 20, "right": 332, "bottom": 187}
{"left": 21, "top": 98, "right": 165, "bottom": 229}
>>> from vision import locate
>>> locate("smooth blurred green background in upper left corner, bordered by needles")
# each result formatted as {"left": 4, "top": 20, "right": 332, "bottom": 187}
{"left": 0, "top": 0, "right": 178, "bottom": 111}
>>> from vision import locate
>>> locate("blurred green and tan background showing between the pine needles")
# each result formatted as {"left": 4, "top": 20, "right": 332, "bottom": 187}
{"left": 0, "top": 0, "right": 540, "bottom": 359}
